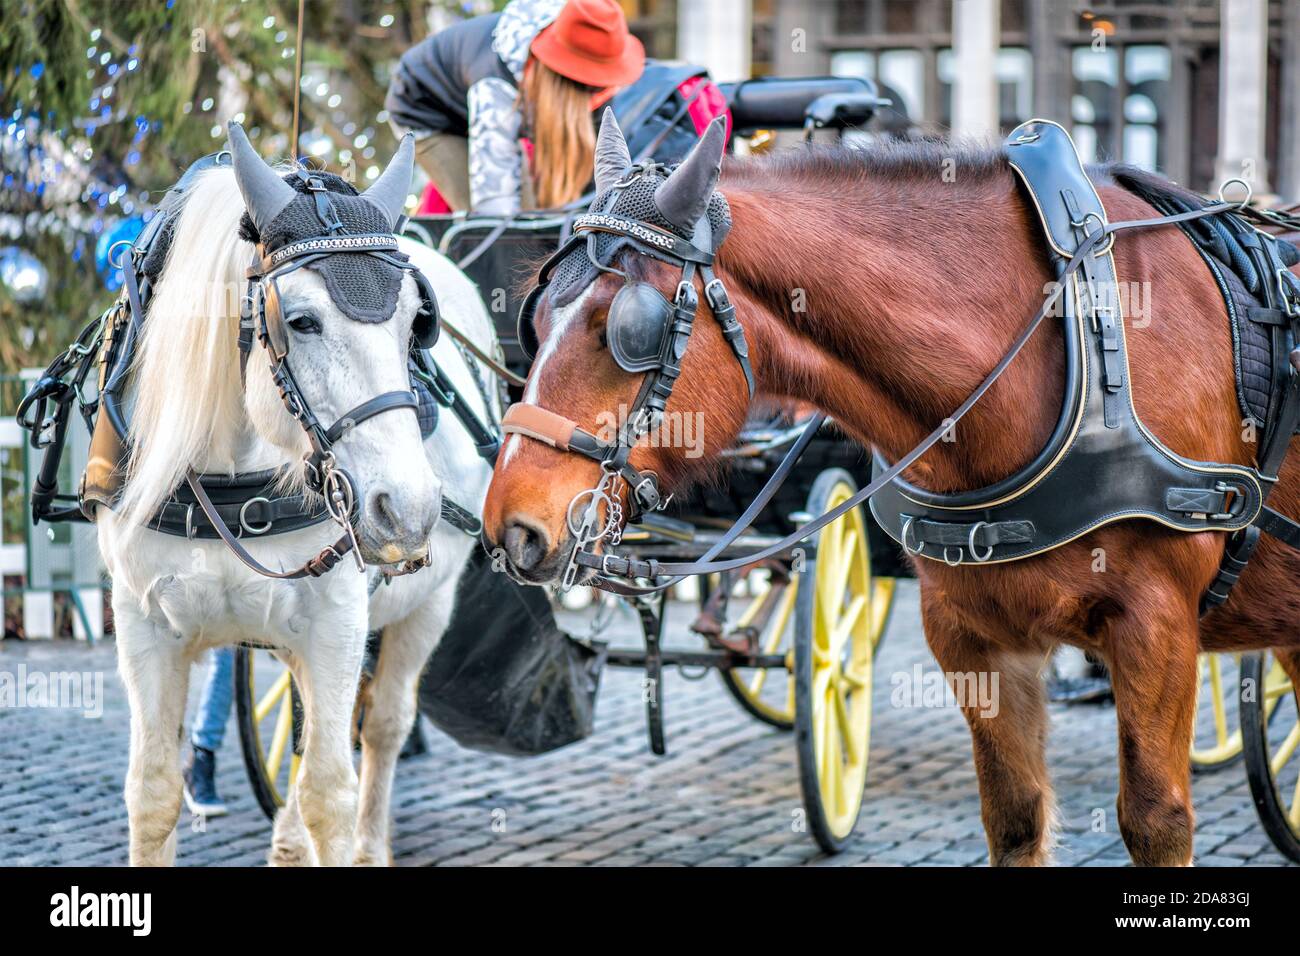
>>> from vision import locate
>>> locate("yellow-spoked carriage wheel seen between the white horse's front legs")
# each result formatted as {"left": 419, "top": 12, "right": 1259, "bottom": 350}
{"left": 235, "top": 645, "right": 303, "bottom": 818}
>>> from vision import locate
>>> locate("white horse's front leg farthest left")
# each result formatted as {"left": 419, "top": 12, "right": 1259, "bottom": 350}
{"left": 113, "top": 600, "right": 191, "bottom": 866}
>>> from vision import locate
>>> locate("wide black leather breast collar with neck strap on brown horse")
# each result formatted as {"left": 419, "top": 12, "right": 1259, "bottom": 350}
{"left": 871, "top": 121, "right": 1271, "bottom": 580}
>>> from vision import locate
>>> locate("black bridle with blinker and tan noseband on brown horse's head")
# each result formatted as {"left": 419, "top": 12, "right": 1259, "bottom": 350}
{"left": 502, "top": 164, "right": 754, "bottom": 591}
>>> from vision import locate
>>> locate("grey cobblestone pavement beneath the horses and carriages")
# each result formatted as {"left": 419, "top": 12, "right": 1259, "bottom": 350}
{"left": 0, "top": 581, "right": 1284, "bottom": 866}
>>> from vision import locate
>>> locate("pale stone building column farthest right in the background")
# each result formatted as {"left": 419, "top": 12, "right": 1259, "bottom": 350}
{"left": 1212, "top": 0, "right": 1269, "bottom": 196}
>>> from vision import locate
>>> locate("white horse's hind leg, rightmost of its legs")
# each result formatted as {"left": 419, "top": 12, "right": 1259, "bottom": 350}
{"left": 356, "top": 575, "right": 456, "bottom": 866}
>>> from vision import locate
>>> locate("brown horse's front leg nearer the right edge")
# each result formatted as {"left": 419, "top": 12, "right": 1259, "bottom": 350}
{"left": 1104, "top": 601, "right": 1199, "bottom": 866}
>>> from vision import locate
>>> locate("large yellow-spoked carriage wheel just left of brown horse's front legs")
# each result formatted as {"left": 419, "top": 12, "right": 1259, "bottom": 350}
{"left": 794, "top": 468, "right": 894, "bottom": 853}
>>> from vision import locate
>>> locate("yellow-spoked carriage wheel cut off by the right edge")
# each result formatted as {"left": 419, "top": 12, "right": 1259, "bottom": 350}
{"left": 1240, "top": 654, "right": 1300, "bottom": 862}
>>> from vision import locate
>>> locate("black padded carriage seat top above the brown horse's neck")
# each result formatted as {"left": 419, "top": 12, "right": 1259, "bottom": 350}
{"left": 719, "top": 77, "right": 888, "bottom": 135}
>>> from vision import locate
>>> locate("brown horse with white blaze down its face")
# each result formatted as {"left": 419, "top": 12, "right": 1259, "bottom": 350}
{"left": 484, "top": 117, "right": 1300, "bottom": 865}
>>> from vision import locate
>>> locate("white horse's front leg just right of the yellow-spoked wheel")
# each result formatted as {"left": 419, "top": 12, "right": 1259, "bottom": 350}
{"left": 286, "top": 613, "right": 365, "bottom": 866}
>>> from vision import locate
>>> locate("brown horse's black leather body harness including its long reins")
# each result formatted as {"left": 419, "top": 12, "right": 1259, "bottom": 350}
{"left": 520, "top": 120, "right": 1300, "bottom": 607}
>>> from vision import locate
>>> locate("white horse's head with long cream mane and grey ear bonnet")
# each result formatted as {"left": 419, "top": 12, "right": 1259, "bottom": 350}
{"left": 122, "top": 126, "right": 441, "bottom": 563}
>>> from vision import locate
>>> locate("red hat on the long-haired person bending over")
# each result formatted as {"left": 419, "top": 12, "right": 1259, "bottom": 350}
{"left": 532, "top": 0, "right": 646, "bottom": 87}
